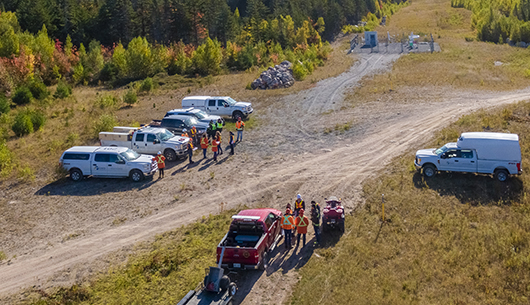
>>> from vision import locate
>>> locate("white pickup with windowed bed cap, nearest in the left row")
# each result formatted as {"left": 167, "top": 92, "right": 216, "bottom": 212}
{"left": 59, "top": 146, "right": 158, "bottom": 182}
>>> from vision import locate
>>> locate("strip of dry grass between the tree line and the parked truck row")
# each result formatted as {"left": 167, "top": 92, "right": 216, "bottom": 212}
{"left": 0, "top": 35, "right": 354, "bottom": 183}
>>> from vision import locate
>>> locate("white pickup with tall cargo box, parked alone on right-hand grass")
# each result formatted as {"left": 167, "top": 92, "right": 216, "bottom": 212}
{"left": 414, "top": 132, "right": 522, "bottom": 181}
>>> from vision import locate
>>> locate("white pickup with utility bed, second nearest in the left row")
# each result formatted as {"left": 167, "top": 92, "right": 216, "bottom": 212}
{"left": 99, "top": 127, "right": 190, "bottom": 161}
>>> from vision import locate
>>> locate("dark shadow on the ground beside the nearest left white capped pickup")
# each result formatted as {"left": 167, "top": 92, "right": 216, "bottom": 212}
{"left": 35, "top": 173, "right": 158, "bottom": 196}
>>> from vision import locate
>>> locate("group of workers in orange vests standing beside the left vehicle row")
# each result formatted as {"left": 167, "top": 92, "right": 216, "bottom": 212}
{"left": 153, "top": 117, "right": 245, "bottom": 175}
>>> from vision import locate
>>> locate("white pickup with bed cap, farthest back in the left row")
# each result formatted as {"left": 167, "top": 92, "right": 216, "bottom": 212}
{"left": 182, "top": 96, "right": 254, "bottom": 120}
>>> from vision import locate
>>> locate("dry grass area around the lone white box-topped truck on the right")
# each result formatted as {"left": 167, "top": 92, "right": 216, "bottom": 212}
{"left": 290, "top": 103, "right": 530, "bottom": 304}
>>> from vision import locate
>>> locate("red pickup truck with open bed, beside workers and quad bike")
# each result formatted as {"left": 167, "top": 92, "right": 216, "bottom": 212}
{"left": 217, "top": 209, "right": 282, "bottom": 270}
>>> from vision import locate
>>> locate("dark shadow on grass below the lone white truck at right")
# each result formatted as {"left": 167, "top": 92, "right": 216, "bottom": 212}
{"left": 412, "top": 172, "right": 523, "bottom": 205}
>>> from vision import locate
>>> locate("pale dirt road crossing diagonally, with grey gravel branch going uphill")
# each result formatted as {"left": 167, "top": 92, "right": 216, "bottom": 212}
{"left": 0, "top": 50, "right": 530, "bottom": 304}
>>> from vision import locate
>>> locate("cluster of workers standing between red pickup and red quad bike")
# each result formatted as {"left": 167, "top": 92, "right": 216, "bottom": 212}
{"left": 281, "top": 194, "right": 320, "bottom": 250}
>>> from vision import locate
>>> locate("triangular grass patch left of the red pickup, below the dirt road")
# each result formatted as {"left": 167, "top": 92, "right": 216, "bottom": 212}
{"left": 29, "top": 210, "right": 237, "bottom": 305}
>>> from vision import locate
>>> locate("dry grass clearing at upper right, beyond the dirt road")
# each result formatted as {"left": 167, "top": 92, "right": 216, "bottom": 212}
{"left": 355, "top": 0, "right": 530, "bottom": 100}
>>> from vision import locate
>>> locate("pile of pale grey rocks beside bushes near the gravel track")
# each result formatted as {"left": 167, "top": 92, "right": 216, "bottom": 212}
{"left": 250, "top": 60, "right": 294, "bottom": 90}
